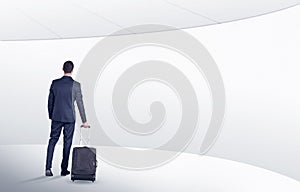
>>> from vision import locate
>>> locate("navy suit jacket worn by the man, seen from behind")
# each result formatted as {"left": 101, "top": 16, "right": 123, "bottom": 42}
{"left": 48, "top": 76, "right": 86, "bottom": 123}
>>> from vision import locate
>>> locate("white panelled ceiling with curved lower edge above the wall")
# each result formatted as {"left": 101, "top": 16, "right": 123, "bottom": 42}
{"left": 0, "top": 0, "right": 300, "bottom": 40}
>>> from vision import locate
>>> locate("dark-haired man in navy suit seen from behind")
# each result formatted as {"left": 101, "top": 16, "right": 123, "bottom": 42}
{"left": 45, "top": 61, "right": 89, "bottom": 176}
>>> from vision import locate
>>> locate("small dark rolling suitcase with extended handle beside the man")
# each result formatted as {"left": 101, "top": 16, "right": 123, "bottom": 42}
{"left": 71, "top": 126, "right": 97, "bottom": 182}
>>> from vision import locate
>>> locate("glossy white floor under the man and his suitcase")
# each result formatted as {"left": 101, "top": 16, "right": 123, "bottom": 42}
{"left": 0, "top": 145, "right": 300, "bottom": 192}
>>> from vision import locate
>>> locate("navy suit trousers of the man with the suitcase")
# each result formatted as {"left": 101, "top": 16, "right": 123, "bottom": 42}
{"left": 46, "top": 120, "right": 75, "bottom": 171}
